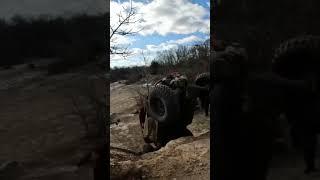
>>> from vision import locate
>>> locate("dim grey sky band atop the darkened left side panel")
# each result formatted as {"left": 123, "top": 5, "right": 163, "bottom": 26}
{"left": 0, "top": 0, "right": 109, "bottom": 19}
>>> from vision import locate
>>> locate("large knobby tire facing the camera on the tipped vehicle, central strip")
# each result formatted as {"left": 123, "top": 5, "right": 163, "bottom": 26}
{"left": 148, "top": 84, "right": 180, "bottom": 125}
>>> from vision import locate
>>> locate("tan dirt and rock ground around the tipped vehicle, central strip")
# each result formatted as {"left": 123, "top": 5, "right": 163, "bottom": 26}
{"left": 110, "top": 82, "right": 210, "bottom": 180}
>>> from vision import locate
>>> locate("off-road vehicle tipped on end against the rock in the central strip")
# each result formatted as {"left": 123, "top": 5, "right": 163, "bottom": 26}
{"left": 139, "top": 73, "right": 210, "bottom": 152}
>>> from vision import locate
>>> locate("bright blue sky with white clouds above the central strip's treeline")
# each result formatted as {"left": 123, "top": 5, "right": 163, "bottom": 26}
{"left": 110, "top": 0, "right": 210, "bottom": 68}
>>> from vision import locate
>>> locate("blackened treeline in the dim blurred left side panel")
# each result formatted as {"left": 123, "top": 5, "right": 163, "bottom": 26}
{"left": 0, "top": 14, "right": 107, "bottom": 66}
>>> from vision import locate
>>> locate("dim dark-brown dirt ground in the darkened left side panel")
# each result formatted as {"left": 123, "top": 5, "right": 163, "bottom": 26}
{"left": 0, "top": 61, "right": 106, "bottom": 180}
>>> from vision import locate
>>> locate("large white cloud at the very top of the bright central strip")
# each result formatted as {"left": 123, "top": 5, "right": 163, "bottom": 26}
{"left": 110, "top": 0, "right": 210, "bottom": 35}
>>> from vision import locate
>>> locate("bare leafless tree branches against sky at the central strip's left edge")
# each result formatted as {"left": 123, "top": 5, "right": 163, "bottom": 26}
{"left": 110, "top": 1, "right": 142, "bottom": 57}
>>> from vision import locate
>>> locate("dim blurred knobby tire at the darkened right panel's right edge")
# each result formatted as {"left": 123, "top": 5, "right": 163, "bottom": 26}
{"left": 272, "top": 35, "right": 320, "bottom": 79}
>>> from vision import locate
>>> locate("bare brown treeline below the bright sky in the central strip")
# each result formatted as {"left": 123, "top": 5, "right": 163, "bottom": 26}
{"left": 110, "top": 40, "right": 210, "bottom": 84}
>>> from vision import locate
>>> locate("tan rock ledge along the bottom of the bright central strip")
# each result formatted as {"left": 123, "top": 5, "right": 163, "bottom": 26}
{"left": 111, "top": 133, "right": 210, "bottom": 180}
